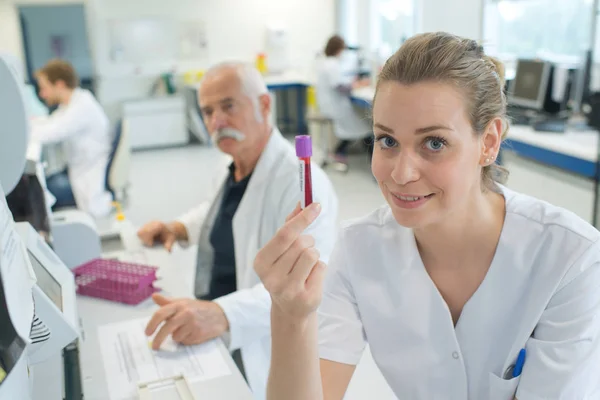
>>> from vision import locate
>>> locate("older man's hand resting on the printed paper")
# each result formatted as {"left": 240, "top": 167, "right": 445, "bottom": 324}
{"left": 146, "top": 293, "right": 229, "bottom": 350}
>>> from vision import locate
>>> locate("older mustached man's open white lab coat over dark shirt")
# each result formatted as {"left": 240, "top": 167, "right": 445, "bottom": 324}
{"left": 179, "top": 129, "right": 338, "bottom": 400}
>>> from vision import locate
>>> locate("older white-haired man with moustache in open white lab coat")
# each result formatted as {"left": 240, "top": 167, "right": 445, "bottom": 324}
{"left": 138, "top": 63, "right": 338, "bottom": 399}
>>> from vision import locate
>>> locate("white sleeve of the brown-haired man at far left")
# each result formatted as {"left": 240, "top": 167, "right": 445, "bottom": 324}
{"left": 31, "top": 103, "right": 89, "bottom": 143}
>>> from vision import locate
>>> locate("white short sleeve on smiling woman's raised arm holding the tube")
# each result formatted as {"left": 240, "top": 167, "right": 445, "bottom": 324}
{"left": 318, "top": 233, "right": 366, "bottom": 365}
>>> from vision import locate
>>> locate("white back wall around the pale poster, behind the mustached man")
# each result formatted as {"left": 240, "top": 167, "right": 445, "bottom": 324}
{"left": 0, "top": 0, "right": 335, "bottom": 119}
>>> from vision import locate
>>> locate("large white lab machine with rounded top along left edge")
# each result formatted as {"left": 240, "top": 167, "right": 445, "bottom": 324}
{"left": 0, "top": 56, "right": 91, "bottom": 400}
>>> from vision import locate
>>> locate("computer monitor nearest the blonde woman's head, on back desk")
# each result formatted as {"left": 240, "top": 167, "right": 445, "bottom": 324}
{"left": 508, "top": 59, "right": 552, "bottom": 111}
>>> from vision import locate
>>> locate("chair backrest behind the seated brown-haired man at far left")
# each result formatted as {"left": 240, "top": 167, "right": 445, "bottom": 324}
{"left": 105, "top": 120, "right": 131, "bottom": 200}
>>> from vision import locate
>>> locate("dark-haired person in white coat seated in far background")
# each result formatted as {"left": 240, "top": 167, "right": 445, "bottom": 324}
{"left": 316, "top": 35, "right": 371, "bottom": 171}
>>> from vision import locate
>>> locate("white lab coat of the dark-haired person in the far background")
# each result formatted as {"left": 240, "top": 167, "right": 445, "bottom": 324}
{"left": 316, "top": 57, "right": 371, "bottom": 140}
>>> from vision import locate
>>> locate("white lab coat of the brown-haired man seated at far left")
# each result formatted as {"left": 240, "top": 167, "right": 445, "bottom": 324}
{"left": 31, "top": 88, "right": 112, "bottom": 217}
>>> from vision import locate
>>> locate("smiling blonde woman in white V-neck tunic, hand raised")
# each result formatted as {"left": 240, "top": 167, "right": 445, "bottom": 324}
{"left": 256, "top": 32, "right": 600, "bottom": 400}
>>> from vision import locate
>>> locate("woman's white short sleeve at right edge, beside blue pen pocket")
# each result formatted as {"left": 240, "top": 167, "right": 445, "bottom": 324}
{"left": 516, "top": 243, "right": 600, "bottom": 400}
